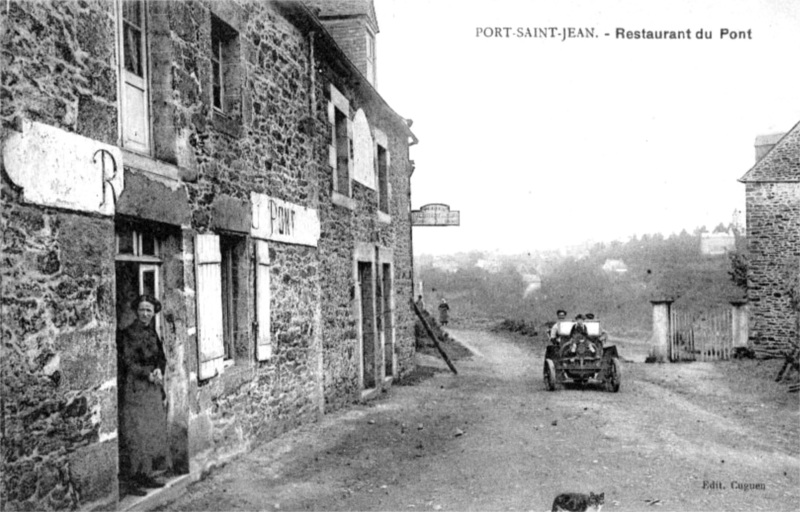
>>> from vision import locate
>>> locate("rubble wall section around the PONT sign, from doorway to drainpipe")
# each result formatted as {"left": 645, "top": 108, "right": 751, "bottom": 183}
{"left": 150, "top": 2, "right": 321, "bottom": 473}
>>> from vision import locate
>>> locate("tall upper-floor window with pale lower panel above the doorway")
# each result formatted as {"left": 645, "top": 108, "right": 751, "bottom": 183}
{"left": 117, "top": 0, "right": 150, "bottom": 153}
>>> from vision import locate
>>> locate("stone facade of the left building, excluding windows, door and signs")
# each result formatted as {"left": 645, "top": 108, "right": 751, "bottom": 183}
{"left": 0, "top": 0, "right": 414, "bottom": 509}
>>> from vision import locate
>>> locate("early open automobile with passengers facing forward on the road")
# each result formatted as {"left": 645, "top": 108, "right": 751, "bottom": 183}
{"left": 544, "top": 320, "right": 622, "bottom": 392}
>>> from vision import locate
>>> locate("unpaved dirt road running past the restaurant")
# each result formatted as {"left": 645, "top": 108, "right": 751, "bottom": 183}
{"left": 158, "top": 331, "right": 800, "bottom": 511}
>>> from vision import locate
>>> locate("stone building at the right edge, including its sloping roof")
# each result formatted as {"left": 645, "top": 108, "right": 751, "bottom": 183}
{"left": 740, "top": 123, "right": 800, "bottom": 357}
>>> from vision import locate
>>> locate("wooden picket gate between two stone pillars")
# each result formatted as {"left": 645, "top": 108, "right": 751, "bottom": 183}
{"left": 669, "top": 308, "right": 733, "bottom": 361}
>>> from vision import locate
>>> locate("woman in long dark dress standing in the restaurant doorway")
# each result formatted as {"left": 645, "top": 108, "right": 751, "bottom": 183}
{"left": 118, "top": 295, "right": 168, "bottom": 494}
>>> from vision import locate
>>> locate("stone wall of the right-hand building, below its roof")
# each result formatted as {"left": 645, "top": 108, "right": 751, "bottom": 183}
{"left": 746, "top": 182, "right": 800, "bottom": 357}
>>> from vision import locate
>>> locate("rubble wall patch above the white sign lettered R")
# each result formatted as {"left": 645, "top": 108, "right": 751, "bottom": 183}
{"left": 0, "top": 0, "right": 117, "bottom": 144}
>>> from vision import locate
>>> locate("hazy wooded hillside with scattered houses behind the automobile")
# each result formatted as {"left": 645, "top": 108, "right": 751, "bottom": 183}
{"left": 417, "top": 229, "right": 744, "bottom": 335}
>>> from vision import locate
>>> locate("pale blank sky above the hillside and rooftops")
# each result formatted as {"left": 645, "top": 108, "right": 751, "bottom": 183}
{"left": 375, "top": 0, "right": 800, "bottom": 254}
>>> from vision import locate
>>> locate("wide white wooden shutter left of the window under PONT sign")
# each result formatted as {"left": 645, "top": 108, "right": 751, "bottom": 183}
{"left": 195, "top": 235, "right": 225, "bottom": 380}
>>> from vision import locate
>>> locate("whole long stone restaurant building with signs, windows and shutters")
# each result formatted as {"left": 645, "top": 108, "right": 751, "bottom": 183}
{"left": 0, "top": 0, "right": 416, "bottom": 510}
